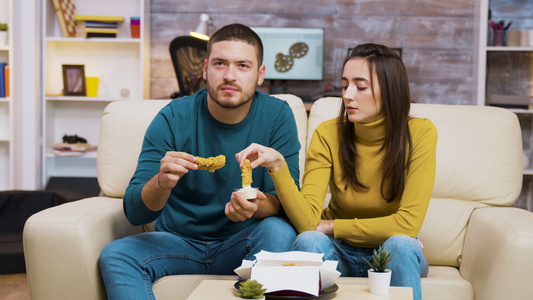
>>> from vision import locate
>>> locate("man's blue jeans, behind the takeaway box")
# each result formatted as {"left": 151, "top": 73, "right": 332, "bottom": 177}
{"left": 96, "top": 217, "right": 296, "bottom": 300}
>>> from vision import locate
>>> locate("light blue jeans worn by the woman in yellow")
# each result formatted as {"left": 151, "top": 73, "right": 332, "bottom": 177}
{"left": 292, "top": 231, "right": 429, "bottom": 300}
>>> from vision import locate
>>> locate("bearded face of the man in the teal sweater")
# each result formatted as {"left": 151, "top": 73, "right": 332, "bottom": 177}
{"left": 204, "top": 41, "right": 265, "bottom": 108}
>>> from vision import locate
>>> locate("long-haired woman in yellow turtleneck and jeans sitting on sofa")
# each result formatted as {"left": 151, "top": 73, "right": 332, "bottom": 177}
{"left": 236, "top": 44, "right": 437, "bottom": 299}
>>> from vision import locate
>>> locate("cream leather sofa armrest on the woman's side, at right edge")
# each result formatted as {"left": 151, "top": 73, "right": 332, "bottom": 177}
{"left": 459, "top": 207, "right": 533, "bottom": 300}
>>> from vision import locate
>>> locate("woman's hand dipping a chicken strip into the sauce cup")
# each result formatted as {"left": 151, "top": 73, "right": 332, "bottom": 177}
{"left": 235, "top": 143, "right": 287, "bottom": 173}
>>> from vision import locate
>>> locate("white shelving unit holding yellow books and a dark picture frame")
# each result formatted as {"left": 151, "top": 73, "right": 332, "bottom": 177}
{"left": 42, "top": 0, "right": 150, "bottom": 186}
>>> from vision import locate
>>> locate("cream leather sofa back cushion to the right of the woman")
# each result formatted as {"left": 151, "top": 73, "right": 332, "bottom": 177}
{"left": 411, "top": 104, "right": 522, "bottom": 206}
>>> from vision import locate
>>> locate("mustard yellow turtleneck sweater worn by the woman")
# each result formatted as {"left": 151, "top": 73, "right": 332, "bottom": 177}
{"left": 270, "top": 118, "right": 437, "bottom": 247}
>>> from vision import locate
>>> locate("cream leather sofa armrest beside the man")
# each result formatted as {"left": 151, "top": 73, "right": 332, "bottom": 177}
{"left": 23, "top": 197, "right": 141, "bottom": 300}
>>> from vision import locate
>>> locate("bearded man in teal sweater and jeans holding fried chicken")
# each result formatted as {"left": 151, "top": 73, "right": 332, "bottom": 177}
{"left": 100, "top": 24, "right": 300, "bottom": 299}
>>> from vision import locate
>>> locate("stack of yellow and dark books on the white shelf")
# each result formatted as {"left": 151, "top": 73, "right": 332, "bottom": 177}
{"left": 75, "top": 15, "right": 124, "bottom": 38}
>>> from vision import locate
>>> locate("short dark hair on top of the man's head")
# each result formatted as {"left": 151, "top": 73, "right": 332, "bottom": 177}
{"left": 207, "top": 23, "right": 263, "bottom": 66}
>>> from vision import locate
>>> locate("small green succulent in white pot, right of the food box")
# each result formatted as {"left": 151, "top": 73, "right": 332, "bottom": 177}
{"left": 363, "top": 247, "right": 392, "bottom": 295}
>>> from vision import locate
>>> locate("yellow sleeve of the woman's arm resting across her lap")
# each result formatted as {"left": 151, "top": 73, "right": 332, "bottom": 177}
{"left": 334, "top": 119, "right": 437, "bottom": 246}
